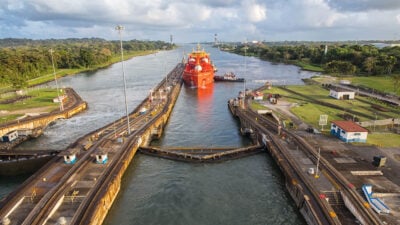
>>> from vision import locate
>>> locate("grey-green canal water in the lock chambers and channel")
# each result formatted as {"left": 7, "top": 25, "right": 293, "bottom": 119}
{"left": 0, "top": 45, "right": 315, "bottom": 225}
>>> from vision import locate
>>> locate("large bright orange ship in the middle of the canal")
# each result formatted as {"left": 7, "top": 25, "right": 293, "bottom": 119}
{"left": 183, "top": 45, "right": 215, "bottom": 88}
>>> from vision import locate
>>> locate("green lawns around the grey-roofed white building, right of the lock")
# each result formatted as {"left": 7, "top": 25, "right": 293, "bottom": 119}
{"left": 252, "top": 85, "right": 400, "bottom": 147}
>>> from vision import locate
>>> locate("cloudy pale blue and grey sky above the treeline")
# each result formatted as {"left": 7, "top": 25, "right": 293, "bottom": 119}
{"left": 0, "top": 0, "right": 400, "bottom": 43}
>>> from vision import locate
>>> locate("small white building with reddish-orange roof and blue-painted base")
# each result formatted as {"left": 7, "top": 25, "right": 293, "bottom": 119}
{"left": 331, "top": 121, "right": 368, "bottom": 143}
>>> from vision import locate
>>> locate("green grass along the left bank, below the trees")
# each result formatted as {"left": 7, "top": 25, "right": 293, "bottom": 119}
{"left": 0, "top": 51, "right": 155, "bottom": 124}
